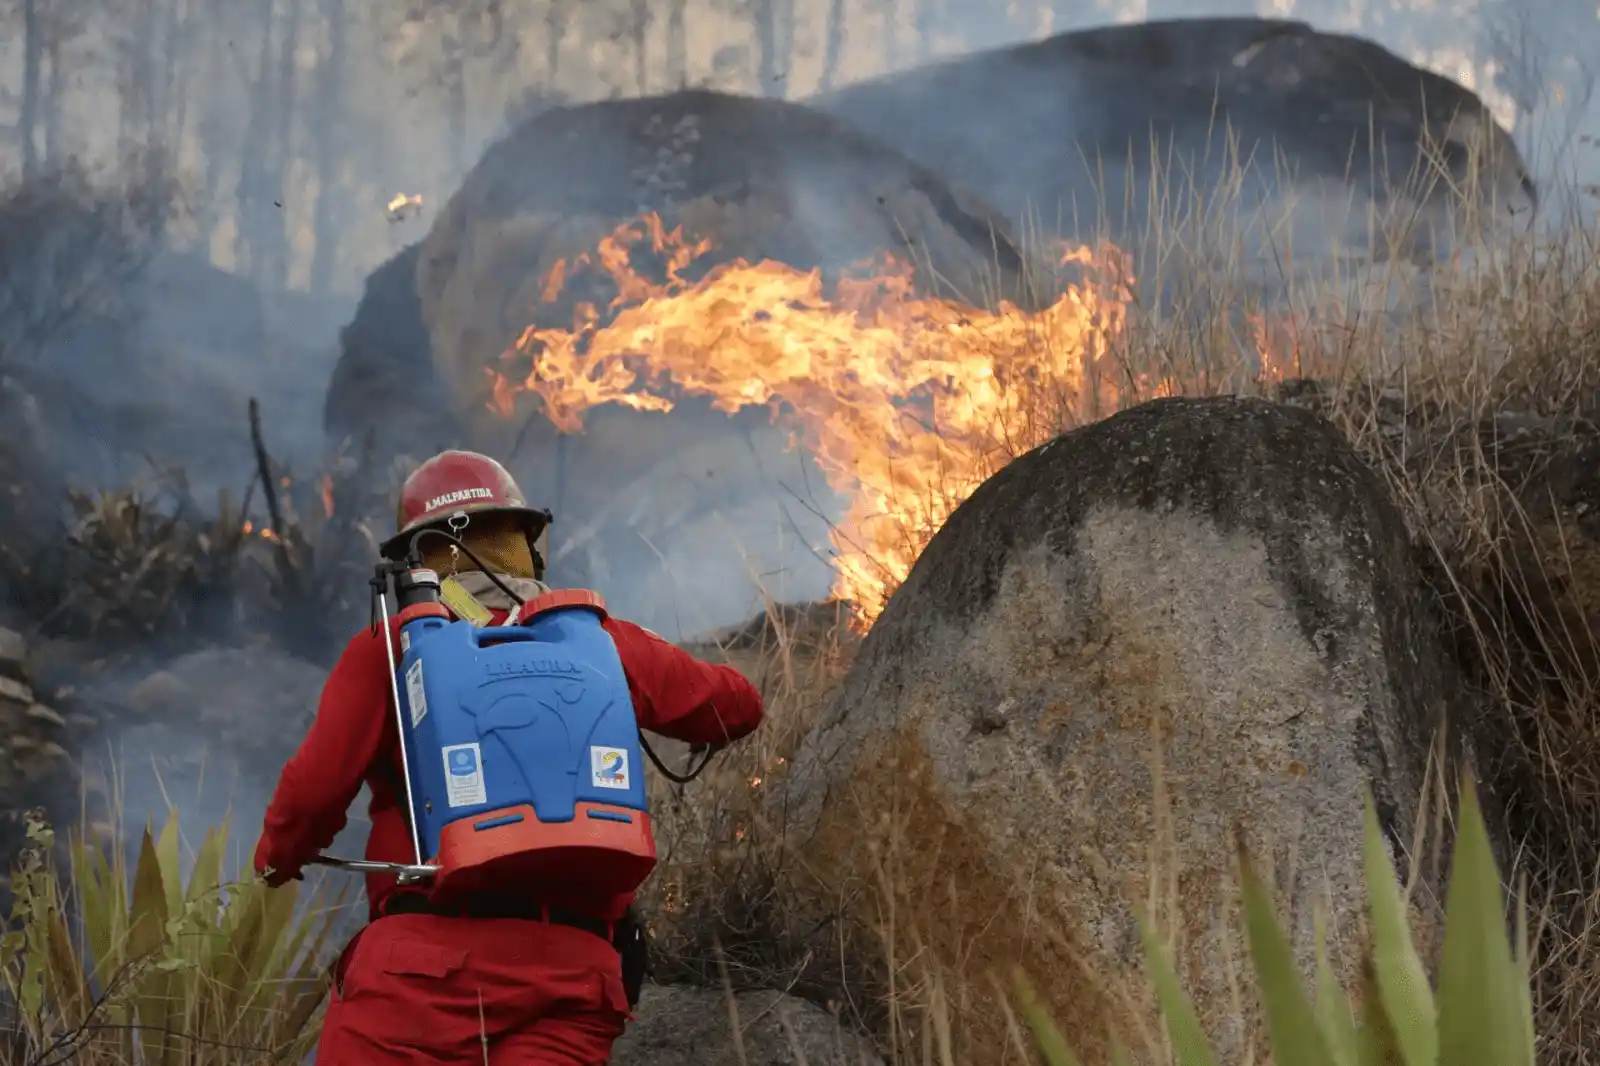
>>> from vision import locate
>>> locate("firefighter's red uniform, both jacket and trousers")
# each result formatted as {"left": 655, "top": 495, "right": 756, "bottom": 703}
{"left": 254, "top": 601, "right": 762, "bottom": 1066}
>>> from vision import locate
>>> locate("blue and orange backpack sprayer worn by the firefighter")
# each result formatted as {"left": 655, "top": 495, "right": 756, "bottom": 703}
{"left": 312, "top": 527, "right": 715, "bottom": 892}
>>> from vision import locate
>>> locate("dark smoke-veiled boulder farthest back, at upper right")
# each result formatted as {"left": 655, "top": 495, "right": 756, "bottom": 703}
{"left": 808, "top": 18, "right": 1534, "bottom": 284}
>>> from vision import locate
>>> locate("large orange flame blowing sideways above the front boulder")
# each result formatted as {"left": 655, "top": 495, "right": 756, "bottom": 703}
{"left": 490, "top": 216, "right": 1133, "bottom": 627}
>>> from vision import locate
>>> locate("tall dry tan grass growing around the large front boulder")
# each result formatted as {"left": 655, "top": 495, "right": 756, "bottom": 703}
{"left": 633, "top": 145, "right": 1600, "bottom": 1064}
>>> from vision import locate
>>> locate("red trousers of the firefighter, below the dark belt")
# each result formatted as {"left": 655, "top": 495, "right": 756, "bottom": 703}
{"left": 317, "top": 914, "right": 630, "bottom": 1066}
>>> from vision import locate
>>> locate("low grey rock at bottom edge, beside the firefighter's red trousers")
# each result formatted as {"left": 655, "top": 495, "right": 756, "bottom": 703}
{"left": 611, "top": 984, "right": 883, "bottom": 1066}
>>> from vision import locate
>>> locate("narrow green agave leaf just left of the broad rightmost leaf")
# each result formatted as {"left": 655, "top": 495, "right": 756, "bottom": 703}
{"left": 1366, "top": 794, "right": 1438, "bottom": 1066}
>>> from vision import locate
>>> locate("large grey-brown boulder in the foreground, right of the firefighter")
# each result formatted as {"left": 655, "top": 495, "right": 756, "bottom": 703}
{"left": 782, "top": 399, "right": 1474, "bottom": 1060}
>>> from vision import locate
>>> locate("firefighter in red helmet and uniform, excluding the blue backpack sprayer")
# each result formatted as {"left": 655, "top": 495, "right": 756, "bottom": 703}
{"left": 254, "top": 451, "right": 762, "bottom": 1066}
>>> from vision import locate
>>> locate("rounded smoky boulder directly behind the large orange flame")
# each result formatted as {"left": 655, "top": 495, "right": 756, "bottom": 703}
{"left": 418, "top": 91, "right": 1026, "bottom": 425}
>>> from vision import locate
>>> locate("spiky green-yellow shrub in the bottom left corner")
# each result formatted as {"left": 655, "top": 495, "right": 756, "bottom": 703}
{"left": 0, "top": 816, "right": 344, "bottom": 1066}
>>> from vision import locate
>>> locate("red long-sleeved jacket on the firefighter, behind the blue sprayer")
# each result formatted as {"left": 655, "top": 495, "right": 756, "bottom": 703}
{"left": 254, "top": 601, "right": 762, "bottom": 920}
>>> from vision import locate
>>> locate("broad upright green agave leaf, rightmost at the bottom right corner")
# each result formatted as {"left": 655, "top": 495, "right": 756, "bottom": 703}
{"left": 1438, "top": 779, "right": 1533, "bottom": 1066}
